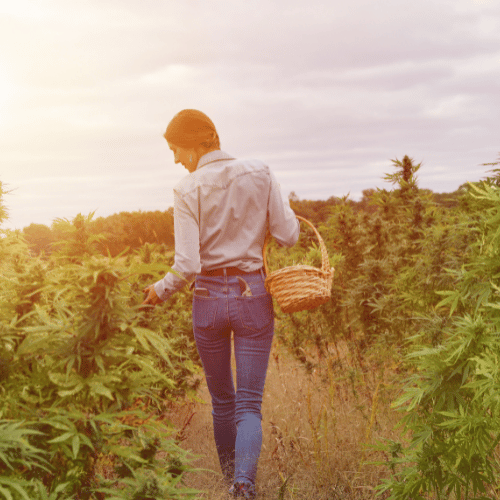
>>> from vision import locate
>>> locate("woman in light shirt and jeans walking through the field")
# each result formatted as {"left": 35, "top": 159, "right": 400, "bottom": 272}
{"left": 144, "top": 109, "right": 299, "bottom": 498}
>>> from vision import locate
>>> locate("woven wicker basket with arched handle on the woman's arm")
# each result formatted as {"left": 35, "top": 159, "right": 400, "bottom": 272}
{"left": 263, "top": 216, "right": 334, "bottom": 313}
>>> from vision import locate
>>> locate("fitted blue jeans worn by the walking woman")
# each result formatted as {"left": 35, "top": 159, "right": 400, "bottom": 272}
{"left": 193, "top": 274, "right": 274, "bottom": 484}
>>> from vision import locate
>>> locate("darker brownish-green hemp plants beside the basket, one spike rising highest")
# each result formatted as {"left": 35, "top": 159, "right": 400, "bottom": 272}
{"left": 274, "top": 156, "right": 447, "bottom": 366}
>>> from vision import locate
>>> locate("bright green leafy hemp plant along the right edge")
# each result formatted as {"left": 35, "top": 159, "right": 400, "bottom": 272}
{"left": 379, "top": 181, "right": 500, "bottom": 500}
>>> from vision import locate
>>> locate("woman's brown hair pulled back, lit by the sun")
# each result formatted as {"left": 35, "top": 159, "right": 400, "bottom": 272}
{"left": 163, "top": 109, "right": 220, "bottom": 148}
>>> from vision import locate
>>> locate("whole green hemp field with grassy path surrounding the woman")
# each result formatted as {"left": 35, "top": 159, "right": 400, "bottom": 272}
{"left": 0, "top": 157, "right": 500, "bottom": 500}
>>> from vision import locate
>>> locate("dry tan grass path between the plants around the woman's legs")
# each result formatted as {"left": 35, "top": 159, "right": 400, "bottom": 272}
{"left": 171, "top": 343, "right": 398, "bottom": 500}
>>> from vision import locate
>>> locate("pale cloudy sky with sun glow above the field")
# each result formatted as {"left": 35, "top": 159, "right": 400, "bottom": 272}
{"left": 0, "top": 0, "right": 500, "bottom": 229}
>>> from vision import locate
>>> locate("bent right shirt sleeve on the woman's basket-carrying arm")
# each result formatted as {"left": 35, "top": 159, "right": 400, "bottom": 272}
{"left": 267, "top": 171, "right": 300, "bottom": 247}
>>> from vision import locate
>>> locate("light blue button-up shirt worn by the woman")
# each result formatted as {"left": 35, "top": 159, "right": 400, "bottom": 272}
{"left": 154, "top": 150, "right": 300, "bottom": 300}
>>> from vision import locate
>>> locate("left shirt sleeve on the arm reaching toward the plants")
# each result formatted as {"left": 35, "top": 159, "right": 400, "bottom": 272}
{"left": 154, "top": 191, "right": 201, "bottom": 301}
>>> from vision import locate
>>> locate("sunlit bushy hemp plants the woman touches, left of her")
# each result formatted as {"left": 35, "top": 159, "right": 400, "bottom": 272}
{"left": 0, "top": 213, "right": 197, "bottom": 500}
